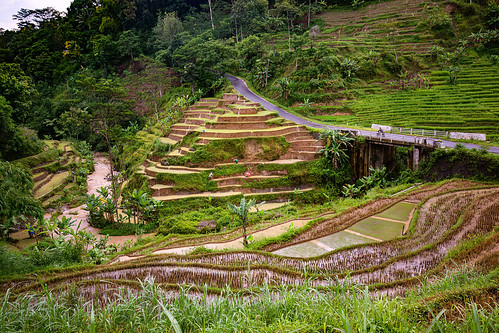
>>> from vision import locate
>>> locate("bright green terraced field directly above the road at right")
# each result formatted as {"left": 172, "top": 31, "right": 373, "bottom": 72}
{"left": 317, "top": 60, "right": 499, "bottom": 140}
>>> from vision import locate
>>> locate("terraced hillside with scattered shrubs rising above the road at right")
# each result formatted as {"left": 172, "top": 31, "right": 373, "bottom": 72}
{"left": 263, "top": 0, "right": 499, "bottom": 142}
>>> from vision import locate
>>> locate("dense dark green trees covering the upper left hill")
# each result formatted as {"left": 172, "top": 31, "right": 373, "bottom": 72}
{"left": 0, "top": 0, "right": 498, "bottom": 160}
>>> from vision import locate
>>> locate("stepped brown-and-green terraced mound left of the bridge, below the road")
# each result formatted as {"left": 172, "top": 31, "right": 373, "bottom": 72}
{"left": 138, "top": 94, "right": 322, "bottom": 201}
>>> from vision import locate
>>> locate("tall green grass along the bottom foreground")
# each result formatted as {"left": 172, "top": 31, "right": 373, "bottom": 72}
{"left": 0, "top": 279, "right": 499, "bottom": 333}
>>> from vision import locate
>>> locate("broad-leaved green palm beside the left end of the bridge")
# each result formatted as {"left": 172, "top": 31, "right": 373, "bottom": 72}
{"left": 319, "top": 129, "right": 354, "bottom": 169}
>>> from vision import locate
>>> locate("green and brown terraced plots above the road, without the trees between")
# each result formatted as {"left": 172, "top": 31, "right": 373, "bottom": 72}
{"left": 267, "top": 0, "right": 499, "bottom": 141}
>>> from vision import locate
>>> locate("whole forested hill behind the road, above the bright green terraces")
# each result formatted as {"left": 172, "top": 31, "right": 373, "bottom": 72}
{"left": 0, "top": 0, "right": 499, "bottom": 160}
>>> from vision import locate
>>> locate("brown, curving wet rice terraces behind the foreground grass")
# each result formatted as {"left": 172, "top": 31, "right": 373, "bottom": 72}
{"left": 0, "top": 181, "right": 499, "bottom": 303}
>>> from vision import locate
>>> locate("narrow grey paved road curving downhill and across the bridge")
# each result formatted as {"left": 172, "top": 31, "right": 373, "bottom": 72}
{"left": 225, "top": 74, "right": 499, "bottom": 154}
